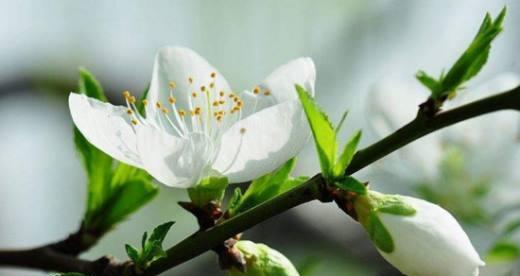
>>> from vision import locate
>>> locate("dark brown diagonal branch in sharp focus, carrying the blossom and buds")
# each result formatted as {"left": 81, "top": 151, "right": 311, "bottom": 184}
{"left": 145, "top": 87, "right": 520, "bottom": 275}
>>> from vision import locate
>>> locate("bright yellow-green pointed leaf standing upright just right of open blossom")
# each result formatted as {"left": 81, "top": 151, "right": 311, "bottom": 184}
{"left": 296, "top": 85, "right": 337, "bottom": 178}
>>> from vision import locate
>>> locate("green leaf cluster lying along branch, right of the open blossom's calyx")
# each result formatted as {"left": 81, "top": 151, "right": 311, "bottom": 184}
{"left": 228, "top": 158, "right": 308, "bottom": 216}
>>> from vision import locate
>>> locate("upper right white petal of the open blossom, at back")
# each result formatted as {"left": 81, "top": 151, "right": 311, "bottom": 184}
{"left": 240, "top": 57, "right": 316, "bottom": 117}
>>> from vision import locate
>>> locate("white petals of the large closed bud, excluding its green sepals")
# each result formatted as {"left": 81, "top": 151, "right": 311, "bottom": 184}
{"left": 379, "top": 197, "right": 484, "bottom": 276}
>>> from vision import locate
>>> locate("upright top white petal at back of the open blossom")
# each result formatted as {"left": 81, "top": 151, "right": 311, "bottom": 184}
{"left": 146, "top": 47, "right": 231, "bottom": 126}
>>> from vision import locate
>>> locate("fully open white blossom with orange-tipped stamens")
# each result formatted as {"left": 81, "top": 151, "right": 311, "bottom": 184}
{"left": 69, "top": 47, "right": 316, "bottom": 187}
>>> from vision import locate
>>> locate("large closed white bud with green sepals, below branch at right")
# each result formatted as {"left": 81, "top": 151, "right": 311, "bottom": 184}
{"left": 354, "top": 191, "right": 484, "bottom": 276}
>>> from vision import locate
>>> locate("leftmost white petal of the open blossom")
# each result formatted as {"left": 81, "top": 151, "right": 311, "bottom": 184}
{"left": 69, "top": 93, "right": 141, "bottom": 167}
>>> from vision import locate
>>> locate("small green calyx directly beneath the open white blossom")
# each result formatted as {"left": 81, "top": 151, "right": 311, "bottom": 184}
{"left": 188, "top": 176, "right": 229, "bottom": 207}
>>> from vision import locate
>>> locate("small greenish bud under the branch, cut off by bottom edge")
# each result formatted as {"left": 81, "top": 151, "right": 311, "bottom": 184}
{"left": 228, "top": 241, "right": 300, "bottom": 276}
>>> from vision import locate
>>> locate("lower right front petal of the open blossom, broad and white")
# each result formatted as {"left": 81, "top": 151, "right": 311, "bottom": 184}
{"left": 213, "top": 101, "right": 310, "bottom": 183}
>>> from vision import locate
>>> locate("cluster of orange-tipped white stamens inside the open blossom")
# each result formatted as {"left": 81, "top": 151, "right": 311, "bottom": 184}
{"left": 123, "top": 72, "right": 271, "bottom": 136}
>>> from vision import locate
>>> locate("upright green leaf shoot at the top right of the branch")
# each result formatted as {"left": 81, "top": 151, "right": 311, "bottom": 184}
{"left": 416, "top": 7, "right": 507, "bottom": 101}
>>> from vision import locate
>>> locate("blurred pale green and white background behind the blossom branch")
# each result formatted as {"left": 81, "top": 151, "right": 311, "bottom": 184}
{"left": 0, "top": 0, "right": 520, "bottom": 276}
